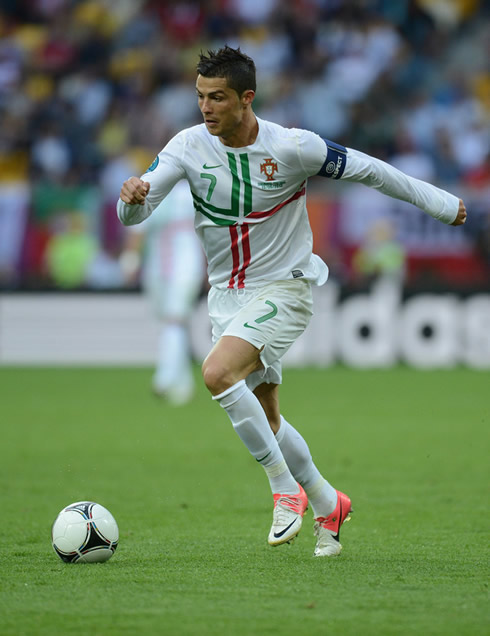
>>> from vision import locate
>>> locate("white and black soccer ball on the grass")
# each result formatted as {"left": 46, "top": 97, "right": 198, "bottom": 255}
{"left": 51, "top": 501, "right": 119, "bottom": 563}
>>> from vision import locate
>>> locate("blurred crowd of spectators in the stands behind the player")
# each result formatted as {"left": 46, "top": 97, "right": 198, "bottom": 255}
{"left": 0, "top": 0, "right": 490, "bottom": 289}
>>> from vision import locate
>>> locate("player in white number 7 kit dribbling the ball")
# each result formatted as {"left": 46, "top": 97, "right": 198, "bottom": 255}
{"left": 117, "top": 46, "right": 466, "bottom": 557}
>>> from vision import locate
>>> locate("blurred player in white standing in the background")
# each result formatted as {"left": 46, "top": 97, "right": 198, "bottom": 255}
{"left": 121, "top": 180, "right": 205, "bottom": 406}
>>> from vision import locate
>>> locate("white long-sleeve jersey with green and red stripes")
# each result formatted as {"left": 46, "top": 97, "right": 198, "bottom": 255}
{"left": 117, "top": 119, "right": 459, "bottom": 289}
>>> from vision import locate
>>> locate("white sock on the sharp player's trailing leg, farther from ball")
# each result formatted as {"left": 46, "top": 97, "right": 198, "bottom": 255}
{"left": 276, "top": 415, "right": 337, "bottom": 518}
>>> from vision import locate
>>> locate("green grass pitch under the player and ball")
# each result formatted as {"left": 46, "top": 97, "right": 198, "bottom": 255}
{"left": 0, "top": 367, "right": 490, "bottom": 636}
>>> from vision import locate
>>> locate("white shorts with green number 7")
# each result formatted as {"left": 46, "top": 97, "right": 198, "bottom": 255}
{"left": 208, "top": 279, "right": 313, "bottom": 389}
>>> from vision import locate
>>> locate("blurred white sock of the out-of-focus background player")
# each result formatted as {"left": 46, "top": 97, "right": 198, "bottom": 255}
{"left": 155, "top": 323, "right": 193, "bottom": 389}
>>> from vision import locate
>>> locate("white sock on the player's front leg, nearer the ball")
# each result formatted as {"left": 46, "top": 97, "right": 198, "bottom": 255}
{"left": 213, "top": 380, "right": 298, "bottom": 495}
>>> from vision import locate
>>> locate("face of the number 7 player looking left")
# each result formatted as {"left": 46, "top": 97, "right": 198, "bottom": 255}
{"left": 196, "top": 75, "right": 253, "bottom": 139}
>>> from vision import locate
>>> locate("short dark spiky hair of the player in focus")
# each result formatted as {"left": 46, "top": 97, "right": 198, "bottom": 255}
{"left": 197, "top": 46, "right": 257, "bottom": 96}
